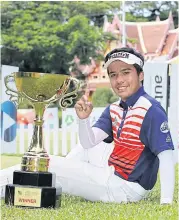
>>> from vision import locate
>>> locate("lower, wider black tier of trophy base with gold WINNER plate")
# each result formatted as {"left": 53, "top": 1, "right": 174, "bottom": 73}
{"left": 5, "top": 184, "right": 62, "bottom": 208}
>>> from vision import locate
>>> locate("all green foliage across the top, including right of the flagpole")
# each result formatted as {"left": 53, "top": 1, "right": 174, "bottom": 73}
{"left": 1, "top": 1, "right": 178, "bottom": 74}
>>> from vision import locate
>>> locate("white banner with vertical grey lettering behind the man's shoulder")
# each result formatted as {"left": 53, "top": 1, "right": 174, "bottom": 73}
{"left": 144, "top": 62, "right": 168, "bottom": 110}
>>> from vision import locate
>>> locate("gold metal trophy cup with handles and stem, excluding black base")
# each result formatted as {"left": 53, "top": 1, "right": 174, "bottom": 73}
{"left": 5, "top": 72, "right": 79, "bottom": 172}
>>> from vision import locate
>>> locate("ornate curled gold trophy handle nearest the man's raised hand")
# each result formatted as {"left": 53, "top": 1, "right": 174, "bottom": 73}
{"left": 59, "top": 77, "right": 80, "bottom": 110}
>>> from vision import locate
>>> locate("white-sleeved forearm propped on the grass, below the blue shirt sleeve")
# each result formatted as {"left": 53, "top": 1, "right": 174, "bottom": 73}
{"left": 158, "top": 150, "right": 175, "bottom": 204}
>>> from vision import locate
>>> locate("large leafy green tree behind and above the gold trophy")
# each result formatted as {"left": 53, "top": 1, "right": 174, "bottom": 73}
{"left": 2, "top": 1, "right": 119, "bottom": 73}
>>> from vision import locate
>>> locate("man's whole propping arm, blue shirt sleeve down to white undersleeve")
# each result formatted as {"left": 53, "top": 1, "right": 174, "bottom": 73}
{"left": 143, "top": 105, "right": 175, "bottom": 204}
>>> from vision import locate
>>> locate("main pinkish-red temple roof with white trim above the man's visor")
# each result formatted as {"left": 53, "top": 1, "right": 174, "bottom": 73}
{"left": 103, "top": 12, "right": 179, "bottom": 59}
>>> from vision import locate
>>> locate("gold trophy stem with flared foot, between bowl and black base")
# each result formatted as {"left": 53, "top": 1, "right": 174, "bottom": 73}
{"left": 21, "top": 102, "right": 49, "bottom": 172}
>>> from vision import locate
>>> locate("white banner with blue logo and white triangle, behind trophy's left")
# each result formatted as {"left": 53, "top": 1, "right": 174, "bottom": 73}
{"left": 1, "top": 65, "right": 19, "bottom": 153}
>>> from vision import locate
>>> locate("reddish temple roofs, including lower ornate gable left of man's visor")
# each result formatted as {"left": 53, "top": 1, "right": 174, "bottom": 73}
{"left": 71, "top": 12, "right": 179, "bottom": 83}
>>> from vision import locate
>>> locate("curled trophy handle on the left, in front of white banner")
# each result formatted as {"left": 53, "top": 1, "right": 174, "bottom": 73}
{"left": 4, "top": 73, "right": 22, "bottom": 106}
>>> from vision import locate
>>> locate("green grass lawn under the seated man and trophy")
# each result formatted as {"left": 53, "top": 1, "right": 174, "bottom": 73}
{"left": 1, "top": 156, "right": 178, "bottom": 220}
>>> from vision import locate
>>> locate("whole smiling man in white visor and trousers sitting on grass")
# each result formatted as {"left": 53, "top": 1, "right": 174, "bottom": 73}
{"left": 1, "top": 48, "right": 174, "bottom": 204}
